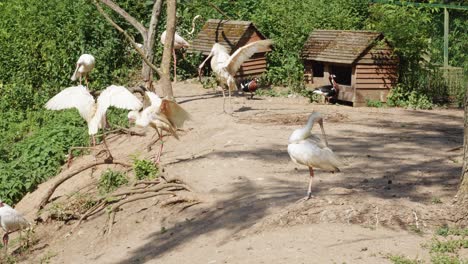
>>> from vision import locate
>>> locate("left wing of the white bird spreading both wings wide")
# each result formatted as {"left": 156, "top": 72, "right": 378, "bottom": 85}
{"left": 45, "top": 85, "right": 94, "bottom": 121}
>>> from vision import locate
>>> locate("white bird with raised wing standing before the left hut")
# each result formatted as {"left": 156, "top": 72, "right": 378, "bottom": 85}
{"left": 198, "top": 39, "right": 272, "bottom": 112}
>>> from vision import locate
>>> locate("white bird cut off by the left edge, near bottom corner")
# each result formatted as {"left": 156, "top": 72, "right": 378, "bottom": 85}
{"left": 0, "top": 200, "right": 31, "bottom": 251}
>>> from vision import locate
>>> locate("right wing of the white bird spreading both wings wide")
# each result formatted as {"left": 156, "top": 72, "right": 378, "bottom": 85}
{"left": 88, "top": 85, "right": 143, "bottom": 135}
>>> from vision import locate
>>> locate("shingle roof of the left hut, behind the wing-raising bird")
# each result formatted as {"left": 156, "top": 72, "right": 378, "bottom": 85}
{"left": 189, "top": 19, "right": 264, "bottom": 55}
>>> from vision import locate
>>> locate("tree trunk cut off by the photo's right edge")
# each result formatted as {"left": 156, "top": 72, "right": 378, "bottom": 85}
{"left": 455, "top": 93, "right": 468, "bottom": 226}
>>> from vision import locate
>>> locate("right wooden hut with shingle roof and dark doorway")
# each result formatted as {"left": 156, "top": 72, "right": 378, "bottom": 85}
{"left": 302, "top": 30, "right": 399, "bottom": 106}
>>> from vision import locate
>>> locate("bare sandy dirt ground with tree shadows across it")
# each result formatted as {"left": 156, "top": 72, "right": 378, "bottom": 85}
{"left": 12, "top": 82, "right": 463, "bottom": 263}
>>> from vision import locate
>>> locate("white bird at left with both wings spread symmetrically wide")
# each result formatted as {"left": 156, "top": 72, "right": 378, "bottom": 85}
{"left": 45, "top": 85, "right": 143, "bottom": 152}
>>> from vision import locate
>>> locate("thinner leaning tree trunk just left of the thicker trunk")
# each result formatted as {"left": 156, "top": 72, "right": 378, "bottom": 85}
{"left": 141, "top": 0, "right": 162, "bottom": 92}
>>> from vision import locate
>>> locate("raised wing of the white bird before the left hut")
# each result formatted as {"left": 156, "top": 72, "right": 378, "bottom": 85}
{"left": 226, "top": 39, "right": 273, "bottom": 75}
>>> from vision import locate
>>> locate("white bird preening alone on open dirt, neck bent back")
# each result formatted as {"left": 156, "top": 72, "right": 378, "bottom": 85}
{"left": 288, "top": 112, "right": 342, "bottom": 199}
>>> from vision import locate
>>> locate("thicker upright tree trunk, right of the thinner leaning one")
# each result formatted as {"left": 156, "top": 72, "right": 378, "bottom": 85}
{"left": 161, "top": 0, "right": 177, "bottom": 99}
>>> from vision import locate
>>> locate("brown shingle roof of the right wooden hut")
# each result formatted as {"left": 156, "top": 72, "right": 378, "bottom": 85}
{"left": 301, "top": 30, "right": 383, "bottom": 64}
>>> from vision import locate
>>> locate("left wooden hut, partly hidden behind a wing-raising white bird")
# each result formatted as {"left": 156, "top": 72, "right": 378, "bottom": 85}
{"left": 188, "top": 19, "right": 270, "bottom": 80}
